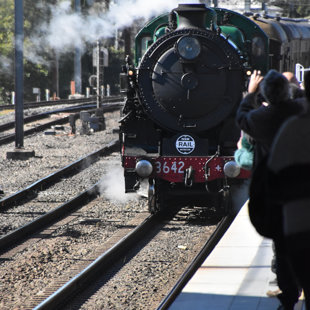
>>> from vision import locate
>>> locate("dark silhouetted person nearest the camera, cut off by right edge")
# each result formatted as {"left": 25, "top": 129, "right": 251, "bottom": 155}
{"left": 268, "top": 72, "right": 310, "bottom": 310}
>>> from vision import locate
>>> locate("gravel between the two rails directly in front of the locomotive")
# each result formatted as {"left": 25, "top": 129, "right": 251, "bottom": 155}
{"left": 77, "top": 220, "right": 215, "bottom": 310}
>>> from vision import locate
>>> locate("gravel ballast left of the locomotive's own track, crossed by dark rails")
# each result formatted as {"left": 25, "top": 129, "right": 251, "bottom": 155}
{"left": 0, "top": 107, "right": 151, "bottom": 309}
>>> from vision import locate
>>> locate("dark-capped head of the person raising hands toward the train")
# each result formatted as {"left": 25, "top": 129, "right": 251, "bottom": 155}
{"left": 260, "top": 69, "right": 290, "bottom": 105}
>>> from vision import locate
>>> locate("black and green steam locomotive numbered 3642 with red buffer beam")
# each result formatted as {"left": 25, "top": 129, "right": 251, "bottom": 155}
{"left": 120, "top": 4, "right": 310, "bottom": 214}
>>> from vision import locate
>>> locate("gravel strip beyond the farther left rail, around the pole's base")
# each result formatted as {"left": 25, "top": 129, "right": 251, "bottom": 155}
{"left": 0, "top": 112, "right": 119, "bottom": 196}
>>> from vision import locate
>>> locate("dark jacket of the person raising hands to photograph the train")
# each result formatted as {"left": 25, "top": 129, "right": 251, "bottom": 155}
{"left": 236, "top": 93, "right": 304, "bottom": 167}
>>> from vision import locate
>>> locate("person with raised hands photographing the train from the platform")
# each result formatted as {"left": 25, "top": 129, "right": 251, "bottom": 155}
{"left": 236, "top": 70, "right": 304, "bottom": 310}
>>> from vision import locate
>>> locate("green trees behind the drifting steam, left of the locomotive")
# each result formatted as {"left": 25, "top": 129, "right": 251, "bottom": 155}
{"left": 0, "top": 0, "right": 119, "bottom": 102}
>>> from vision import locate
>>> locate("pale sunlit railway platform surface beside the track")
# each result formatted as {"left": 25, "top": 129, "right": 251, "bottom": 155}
{"left": 169, "top": 203, "right": 306, "bottom": 310}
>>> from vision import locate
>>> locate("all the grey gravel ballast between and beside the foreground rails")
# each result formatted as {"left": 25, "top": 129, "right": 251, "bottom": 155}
{"left": 0, "top": 107, "right": 214, "bottom": 310}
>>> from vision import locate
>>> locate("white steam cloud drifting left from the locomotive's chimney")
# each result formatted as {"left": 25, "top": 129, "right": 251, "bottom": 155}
{"left": 25, "top": 0, "right": 199, "bottom": 63}
